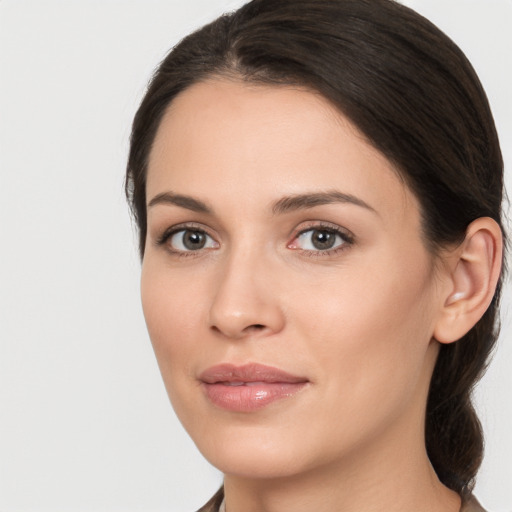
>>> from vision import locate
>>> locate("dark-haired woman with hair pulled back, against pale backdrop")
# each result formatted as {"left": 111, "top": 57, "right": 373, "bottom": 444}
{"left": 127, "top": 0, "right": 503, "bottom": 512}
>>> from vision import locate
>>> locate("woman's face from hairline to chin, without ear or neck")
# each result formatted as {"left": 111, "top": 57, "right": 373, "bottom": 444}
{"left": 142, "top": 80, "right": 446, "bottom": 477}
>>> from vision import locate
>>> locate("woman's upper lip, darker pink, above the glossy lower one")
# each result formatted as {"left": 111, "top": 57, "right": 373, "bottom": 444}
{"left": 199, "top": 363, "right": 308, "bottom": 384}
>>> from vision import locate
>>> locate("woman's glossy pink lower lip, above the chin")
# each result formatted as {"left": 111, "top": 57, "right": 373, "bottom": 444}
{"left": 203, "top": 382, "right": 306, "bottom": 412}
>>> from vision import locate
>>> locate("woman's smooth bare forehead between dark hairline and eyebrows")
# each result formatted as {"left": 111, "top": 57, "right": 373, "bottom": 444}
{"left": 147, "top": 80, "right": 418, "bottom": 222}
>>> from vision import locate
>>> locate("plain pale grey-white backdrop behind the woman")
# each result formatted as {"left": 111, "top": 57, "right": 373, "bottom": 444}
{"left": 0, "top": 0, "right": 512, "bottom": 512}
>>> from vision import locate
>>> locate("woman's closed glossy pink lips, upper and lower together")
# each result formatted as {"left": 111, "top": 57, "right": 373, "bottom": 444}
{"left": 199, "top": 363, "right": 309, "bottom": 412}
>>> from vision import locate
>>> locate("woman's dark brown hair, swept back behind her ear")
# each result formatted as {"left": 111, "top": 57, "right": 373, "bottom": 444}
{"left": 126, "top": 0, "right": 503, "bottom": 499}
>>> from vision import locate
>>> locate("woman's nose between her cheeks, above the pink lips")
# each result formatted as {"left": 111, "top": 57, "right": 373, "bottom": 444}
{"left": 210, "top": 248, "right": 285, "bottom": 339}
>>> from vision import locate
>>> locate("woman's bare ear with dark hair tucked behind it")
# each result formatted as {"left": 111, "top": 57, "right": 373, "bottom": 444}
{"left": 434, "top": 217, "right": 503, "bottom": 343}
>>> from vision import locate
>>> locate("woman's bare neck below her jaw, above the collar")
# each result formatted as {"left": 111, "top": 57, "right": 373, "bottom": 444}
{"left": 224, "top": 410, "right": 461, "bottom": 512}
